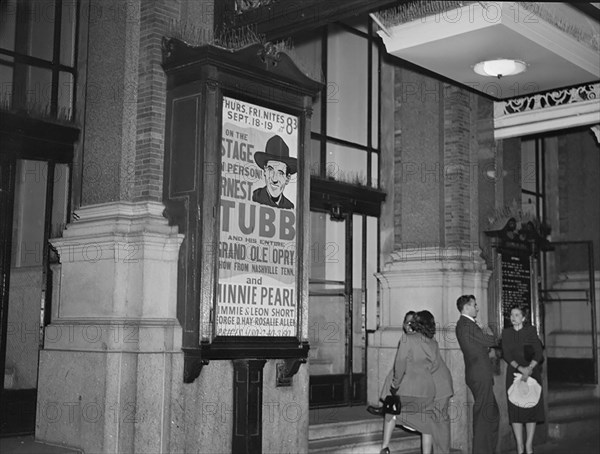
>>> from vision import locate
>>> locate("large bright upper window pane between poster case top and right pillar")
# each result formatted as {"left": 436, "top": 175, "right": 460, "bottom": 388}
{"left": 327, "top": 26, "right": 368, "bottom": 145}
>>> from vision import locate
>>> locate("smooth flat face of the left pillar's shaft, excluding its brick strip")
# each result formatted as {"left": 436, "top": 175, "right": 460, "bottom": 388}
{"left": 76, "top": 0, "right": 140, "bottom": 205}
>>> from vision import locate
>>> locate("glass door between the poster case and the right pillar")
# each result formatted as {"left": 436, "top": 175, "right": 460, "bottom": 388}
{"left": 309, "top": 211, "right": 366, "bottom": 408}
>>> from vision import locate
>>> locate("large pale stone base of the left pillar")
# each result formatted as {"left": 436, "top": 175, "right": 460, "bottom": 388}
{"left": 36, "top": 202, "right": 183, "bottom": 453}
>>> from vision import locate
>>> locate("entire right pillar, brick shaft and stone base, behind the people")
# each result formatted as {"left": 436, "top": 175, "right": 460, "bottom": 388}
{"left": 368, "top": 67, "right": 503, "bottom": 452}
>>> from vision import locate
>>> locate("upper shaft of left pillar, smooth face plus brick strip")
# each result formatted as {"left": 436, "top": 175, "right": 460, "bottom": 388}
{"left": 80, "top": 0, "right": 214, "bottom": 205}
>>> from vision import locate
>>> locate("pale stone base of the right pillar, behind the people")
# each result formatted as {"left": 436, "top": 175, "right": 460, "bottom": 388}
{"left": 367, "top": 248, "right": 492, "bottom": 453}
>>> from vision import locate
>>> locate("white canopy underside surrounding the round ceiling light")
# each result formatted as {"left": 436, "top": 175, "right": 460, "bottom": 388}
{"left": 379, "top": 2, "right": 600, "bottom": 99}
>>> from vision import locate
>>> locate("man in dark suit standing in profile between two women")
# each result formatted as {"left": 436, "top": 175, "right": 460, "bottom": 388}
{"left": 456, "top": 295, "right": 500, "bottom": 454}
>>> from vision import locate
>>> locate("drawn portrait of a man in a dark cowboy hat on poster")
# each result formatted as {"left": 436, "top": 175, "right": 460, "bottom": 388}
{"left": 252, "top": 135, "right": 298, "bottom": 209}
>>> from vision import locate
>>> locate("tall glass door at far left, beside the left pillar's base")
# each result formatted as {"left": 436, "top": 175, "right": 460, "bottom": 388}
{"left": 0, "top": 158, "right": 69, "bottom": 436}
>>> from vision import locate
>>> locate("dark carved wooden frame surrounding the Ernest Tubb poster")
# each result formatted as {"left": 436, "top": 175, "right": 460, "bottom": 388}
{"left": 163, "top": 39, "right": 322, "bottom": 383}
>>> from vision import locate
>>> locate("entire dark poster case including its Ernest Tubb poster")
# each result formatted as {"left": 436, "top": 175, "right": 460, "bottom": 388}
{"left": 163, "top": 39, "right": 322, "bottom": 382}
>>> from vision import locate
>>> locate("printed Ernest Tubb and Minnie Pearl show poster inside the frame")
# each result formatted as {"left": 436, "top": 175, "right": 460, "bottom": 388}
{"left": 215, "top": 97, "right": 298, "bottom": 337}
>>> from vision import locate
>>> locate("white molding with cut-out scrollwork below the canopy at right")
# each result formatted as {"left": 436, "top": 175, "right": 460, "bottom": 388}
{"left": 494, "top": 83, "right": 600, "bottom": 139}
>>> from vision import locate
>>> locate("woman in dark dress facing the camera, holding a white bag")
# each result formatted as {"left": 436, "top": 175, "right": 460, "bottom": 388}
{"left": 502, "top": 306, "right": 544, "bottom": 454}
